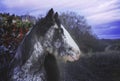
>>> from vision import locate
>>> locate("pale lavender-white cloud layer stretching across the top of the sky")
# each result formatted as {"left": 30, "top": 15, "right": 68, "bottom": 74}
{"left": 2, "top": 0, "right": 120, "bottom": 20}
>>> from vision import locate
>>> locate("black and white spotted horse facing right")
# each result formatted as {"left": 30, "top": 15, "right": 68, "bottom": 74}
{"left": 9, "top": 9, "right": 81, "bottom": 81}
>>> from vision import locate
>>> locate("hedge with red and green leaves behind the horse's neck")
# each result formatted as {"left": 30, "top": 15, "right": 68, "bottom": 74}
{"left": 0, "top": 13, "right": 33, "bottom": 81}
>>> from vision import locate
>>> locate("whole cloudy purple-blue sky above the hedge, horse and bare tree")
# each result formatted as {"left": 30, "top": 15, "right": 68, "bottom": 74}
{"left": 0, "top": 0, "right": 120, "bottom": 39}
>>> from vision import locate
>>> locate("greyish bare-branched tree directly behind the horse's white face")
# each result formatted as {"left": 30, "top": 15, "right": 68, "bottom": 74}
{"left": 60, "top": 12, "right": 104, "bottom": 53}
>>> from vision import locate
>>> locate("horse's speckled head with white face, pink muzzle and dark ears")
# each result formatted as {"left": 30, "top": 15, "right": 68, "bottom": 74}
{"left": 39, "top": 9, "right": 81, "bottom": 61}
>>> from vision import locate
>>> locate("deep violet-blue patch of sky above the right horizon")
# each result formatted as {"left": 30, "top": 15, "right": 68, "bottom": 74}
{"left": 93, "top": 23, "right": 120, "bottom": 39}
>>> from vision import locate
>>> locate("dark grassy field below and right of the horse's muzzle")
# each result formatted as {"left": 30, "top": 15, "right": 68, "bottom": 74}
{"left": 64, "top": 52, "right": 120, "bottom": 81}
